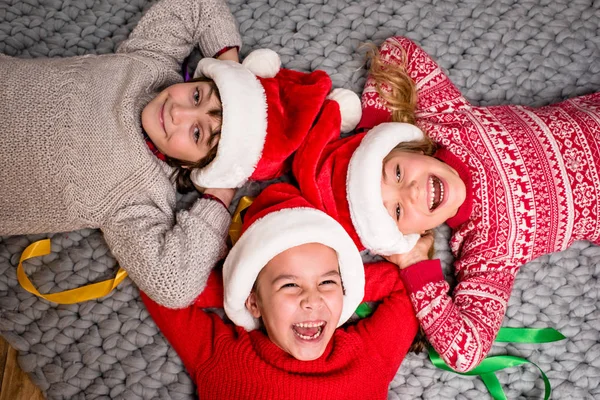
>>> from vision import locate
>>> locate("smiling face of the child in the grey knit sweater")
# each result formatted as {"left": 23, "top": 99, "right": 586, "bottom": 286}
{"left": 142, "top": 81, "right": 222, "bottom": 163}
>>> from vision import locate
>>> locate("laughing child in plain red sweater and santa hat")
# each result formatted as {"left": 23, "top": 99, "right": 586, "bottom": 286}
{"left": 143, "top": 184, "right": 417, "bottom": 400}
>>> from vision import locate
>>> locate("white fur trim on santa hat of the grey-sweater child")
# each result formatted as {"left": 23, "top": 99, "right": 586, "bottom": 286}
{"left": 190, "top": 58, "right": 267, "bottom": 188}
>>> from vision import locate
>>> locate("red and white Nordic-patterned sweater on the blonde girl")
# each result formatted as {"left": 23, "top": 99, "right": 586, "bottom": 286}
{"left": 359, "top": 37, "right": 600, "bottom": 371}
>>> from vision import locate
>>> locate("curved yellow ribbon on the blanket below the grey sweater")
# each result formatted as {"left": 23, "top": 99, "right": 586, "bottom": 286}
{"left": 17, "top": 239, "right": 127, "bottom": 304}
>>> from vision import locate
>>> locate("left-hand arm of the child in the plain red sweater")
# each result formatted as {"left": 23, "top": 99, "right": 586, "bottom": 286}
{"left": 140, "top": 292, "right": 224, "bottom": 377}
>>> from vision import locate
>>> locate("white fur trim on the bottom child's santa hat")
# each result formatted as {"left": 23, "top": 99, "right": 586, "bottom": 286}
{"left": 223, "top": 207, "right": 365, "bottom": 331}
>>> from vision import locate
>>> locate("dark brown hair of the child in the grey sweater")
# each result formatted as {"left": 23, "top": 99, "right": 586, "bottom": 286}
{"left": 165, "top": 76, "right": 223, "bottom": 193}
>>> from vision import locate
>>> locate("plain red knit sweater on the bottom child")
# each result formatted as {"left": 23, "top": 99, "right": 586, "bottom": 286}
{"left": 142, "top": 263, "right": 418, "bottom": 400}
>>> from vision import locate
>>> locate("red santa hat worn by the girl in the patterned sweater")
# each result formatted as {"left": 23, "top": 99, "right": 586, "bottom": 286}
{"left": 292, "top": 120, "right": 424, "bottom": 255}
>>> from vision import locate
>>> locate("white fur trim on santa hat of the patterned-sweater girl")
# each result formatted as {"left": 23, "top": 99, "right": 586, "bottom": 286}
{"left": 346, "top": 122, "right": 424, "bottom": 256}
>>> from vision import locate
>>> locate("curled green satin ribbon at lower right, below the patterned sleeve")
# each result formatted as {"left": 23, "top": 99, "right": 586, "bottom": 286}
{"left": 429, "top": 328, "right": 565, "bottom": 400}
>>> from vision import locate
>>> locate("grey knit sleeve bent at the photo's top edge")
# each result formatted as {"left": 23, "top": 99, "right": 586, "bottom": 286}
{"left": 117, "top": 0, "right": 242, "bottom": 71}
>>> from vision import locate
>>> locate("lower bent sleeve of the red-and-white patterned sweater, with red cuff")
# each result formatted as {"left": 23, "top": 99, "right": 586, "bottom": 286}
{"left": 400, "top": 260, "right": 515, "bottom": 372}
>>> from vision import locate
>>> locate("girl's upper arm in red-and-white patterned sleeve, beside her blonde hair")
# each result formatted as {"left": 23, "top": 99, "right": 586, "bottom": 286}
{"left": 358, "top": 36, "right": 469, "bottom": 129}
